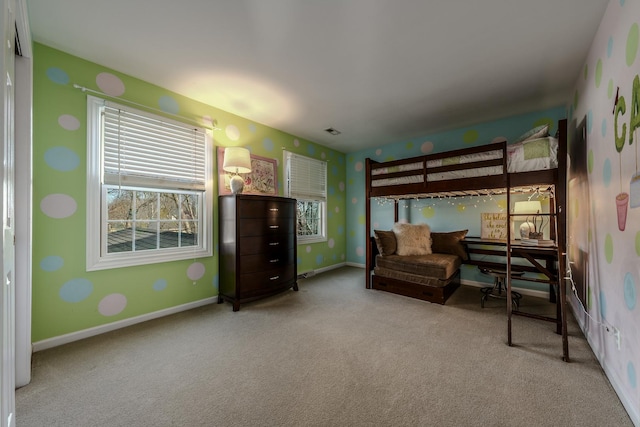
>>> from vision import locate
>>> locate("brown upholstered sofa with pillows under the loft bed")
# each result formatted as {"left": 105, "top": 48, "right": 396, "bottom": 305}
{"left": 372, "top": 223, "right": 468, "bottom": 304}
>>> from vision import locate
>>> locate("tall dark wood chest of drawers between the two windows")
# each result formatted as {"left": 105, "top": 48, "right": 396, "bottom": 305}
{"left": 218, "top": 194, "right": 298, "bottom": 311}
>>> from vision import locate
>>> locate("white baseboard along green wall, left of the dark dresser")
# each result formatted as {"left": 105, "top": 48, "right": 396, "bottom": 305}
{"left": 33, "top": 296, "right": 218, "bottom": 353}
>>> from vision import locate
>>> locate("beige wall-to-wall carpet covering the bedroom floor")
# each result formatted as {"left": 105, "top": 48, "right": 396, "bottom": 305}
{"left": 16, "top": 267, "right": 632, "bottom": 427}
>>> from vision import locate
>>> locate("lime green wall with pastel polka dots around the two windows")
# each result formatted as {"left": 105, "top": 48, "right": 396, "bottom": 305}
{"left": 32, "top": 44, "right": 346, "bottom": 342}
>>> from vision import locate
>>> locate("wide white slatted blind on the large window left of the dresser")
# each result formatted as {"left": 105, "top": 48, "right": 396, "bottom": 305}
{"left": 102, "top": 101, "right": 206, "bottom": 190}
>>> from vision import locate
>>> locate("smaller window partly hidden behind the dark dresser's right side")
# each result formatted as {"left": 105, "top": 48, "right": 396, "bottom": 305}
{"left": 284, "top": 151, "right": 327, "bottom": 243}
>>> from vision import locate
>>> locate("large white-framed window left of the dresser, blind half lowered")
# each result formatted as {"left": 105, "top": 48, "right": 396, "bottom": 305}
{"left": 87, "top": 96, "right": 213, "bottom": 270}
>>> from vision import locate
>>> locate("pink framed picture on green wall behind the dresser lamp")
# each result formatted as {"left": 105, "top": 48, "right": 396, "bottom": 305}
{"left": 218, "top": 147, "right": 278, "bottom": 196}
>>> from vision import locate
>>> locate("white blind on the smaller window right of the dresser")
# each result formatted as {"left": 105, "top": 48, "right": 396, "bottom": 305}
{"left": 285, "top": 151, "right": 327, "bottom": 201}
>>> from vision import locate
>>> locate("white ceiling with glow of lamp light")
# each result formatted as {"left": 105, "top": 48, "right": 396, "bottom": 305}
{"left": 27, "top": 0, "right": 608, "bottom": 152}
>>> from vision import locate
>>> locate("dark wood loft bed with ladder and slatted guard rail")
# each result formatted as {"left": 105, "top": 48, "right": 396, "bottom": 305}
{"left": 365, "top": 119, "right": 569, "bottom": 361}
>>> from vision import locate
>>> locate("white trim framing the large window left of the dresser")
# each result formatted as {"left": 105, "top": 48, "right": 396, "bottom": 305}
{"left": 86, "top": 95, "right": 213, "bottom": 271}
